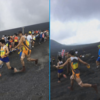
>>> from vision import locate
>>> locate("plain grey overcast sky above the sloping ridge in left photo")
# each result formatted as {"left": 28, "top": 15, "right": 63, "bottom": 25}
{"left": 0, "top": 0, "right": 49, "bottom": 31}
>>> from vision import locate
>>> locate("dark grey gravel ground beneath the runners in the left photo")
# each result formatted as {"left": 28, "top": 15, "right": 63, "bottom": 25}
{"left": 0, "top": 41, "right": 49, "bottom": 100}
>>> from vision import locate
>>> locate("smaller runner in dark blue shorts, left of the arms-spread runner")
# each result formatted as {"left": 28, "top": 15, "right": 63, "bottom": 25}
{"left": 53, "top": 56, "right": 67, "bottom": 83}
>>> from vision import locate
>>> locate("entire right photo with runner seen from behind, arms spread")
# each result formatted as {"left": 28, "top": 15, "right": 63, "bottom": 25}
{"left": 50, "top": 0, "right": 100, "bottom": 100}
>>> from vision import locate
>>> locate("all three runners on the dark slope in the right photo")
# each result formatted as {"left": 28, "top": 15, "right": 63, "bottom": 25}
{"left": 53, "top": 45, "right": 100, "bottom": 93}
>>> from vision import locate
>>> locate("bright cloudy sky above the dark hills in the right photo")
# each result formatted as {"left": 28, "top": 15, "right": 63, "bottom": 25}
{"left": 50, "top": 0, "right": 100, "bottom": 45}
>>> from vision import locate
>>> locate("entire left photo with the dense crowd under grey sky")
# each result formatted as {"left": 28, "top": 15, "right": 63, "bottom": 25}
{"left": 0, "top": 0, "right": 50, "bottom": 100}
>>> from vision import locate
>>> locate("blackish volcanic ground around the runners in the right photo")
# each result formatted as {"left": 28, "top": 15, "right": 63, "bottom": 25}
{"left": 51, "top": 44, "right": 100, "bottom": 100}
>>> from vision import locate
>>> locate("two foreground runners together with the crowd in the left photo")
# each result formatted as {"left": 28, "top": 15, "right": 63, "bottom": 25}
{"left": 0, "top": 31, "right": 49, "bottom": 76}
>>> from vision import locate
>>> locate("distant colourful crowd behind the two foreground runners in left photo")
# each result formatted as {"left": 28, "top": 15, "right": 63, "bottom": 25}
{"left": 1, "top": 30, "right": 49, "bottom": 52}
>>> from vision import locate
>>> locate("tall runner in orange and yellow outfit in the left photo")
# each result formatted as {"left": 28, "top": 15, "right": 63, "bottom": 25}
{"left": 14, "top": 31, "right": 38, "bottom": 72}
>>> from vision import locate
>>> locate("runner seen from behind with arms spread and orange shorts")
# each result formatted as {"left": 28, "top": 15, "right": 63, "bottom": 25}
{"left": 59, "top": 50, "right": 98, "bottom": 92}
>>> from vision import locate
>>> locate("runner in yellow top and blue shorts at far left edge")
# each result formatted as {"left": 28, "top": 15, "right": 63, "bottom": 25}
{"left": 0, "top": 40, "right": 19, "bottom": 76}
